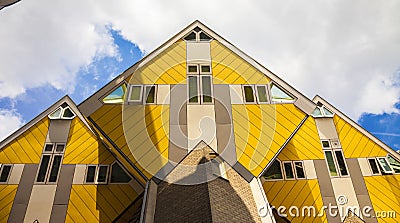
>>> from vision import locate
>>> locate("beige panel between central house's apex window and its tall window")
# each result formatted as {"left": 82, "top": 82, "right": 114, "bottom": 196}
{"left": 186, "top": 42, "right": 211, "bottom": 63}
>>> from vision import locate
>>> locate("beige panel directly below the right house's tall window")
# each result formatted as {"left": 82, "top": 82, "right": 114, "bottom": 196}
{"left": 331, "top": 177, "right": 360, "bottom": 221}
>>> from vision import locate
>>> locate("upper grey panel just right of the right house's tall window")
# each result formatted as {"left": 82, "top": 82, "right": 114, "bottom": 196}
{"left": 346, "top": 158, "right": 371, "bottom": 195}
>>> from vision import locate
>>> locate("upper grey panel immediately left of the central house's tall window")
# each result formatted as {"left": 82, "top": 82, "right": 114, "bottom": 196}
{"left": 169, "top": 84, "right": 187, "bottom": 125}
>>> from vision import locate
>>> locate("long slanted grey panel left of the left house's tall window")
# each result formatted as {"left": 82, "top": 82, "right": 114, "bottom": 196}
{"left": 8, "top": 164, "right": 38, "bottom": 222}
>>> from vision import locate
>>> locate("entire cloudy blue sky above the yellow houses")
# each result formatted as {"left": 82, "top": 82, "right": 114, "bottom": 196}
{"left": 0, "top": 0, "right": 400, "bottom": 150}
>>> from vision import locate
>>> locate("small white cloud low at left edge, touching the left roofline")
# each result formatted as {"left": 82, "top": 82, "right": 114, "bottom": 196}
{"left": 0, "top": 109, "right": 24, "bottom": 141}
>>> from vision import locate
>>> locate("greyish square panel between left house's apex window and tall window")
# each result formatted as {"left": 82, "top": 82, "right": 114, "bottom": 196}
{"left": 47, "top": 120, "right": 71, "bottom": 142}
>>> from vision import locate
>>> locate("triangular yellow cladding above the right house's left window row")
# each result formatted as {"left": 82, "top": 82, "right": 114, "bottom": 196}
{"left": 278, "top": 116, "right": 324, "bottom": 161}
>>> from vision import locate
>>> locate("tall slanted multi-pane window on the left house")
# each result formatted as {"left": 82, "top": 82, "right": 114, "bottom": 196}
{"left": 36, "top": 143, "right": 65, "bottom": 183}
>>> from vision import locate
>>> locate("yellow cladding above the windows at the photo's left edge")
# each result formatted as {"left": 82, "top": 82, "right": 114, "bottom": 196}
{"left": 0, "top": 117, "right": 49, "bottom": 163}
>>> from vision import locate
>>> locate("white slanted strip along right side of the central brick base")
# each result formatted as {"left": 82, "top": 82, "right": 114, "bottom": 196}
{"left": 250, "top": 177, "right": 275, "bottom": 223}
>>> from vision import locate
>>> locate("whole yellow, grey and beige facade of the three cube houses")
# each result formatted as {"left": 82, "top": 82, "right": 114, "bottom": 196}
{"left": 0, "top": 21, "right": 400, "bottom": 222}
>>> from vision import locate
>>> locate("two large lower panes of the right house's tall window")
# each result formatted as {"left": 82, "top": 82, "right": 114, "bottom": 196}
{"left": 324, "top": 150, "right": 349, "bottom": 177}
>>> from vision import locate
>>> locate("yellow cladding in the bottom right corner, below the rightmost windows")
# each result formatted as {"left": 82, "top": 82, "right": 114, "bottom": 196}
{"left": 364, "top": 175, "right": 400, "bottom": 222}
